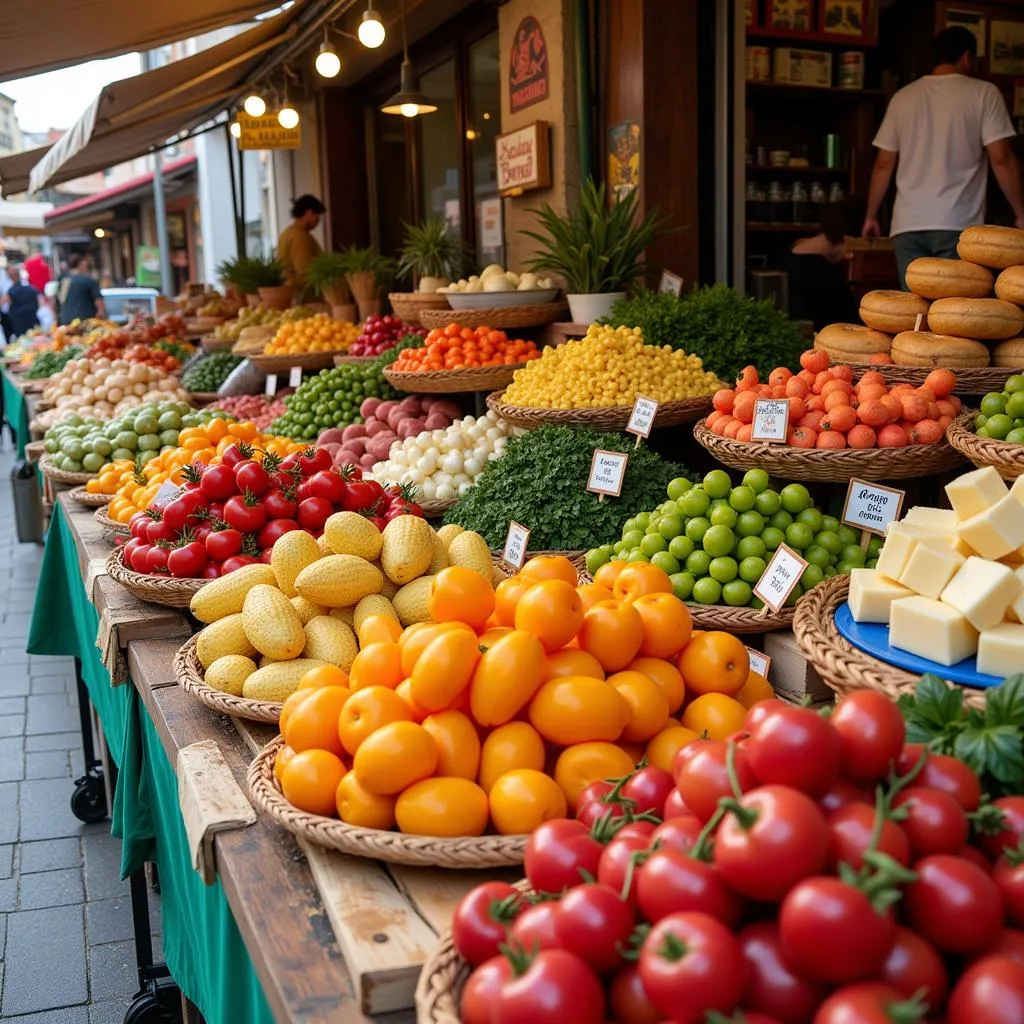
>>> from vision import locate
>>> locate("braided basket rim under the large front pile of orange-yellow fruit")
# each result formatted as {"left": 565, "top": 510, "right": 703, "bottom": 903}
{"left": 248, "top": 736, "right": 528, "bottom": 869}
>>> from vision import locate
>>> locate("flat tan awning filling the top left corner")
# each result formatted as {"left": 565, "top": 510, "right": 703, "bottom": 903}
{"left": 0, "top": 0, "right": 290, "bottom": 80}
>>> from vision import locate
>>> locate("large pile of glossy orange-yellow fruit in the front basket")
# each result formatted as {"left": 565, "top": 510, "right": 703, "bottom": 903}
{"left": 274, "top": 555, "right": 773, "bottom": 837}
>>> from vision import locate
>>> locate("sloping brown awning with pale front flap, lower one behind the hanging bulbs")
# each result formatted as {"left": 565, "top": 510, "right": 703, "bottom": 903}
{"left": 29, "top": 3, "right": 302, "bottom": 191}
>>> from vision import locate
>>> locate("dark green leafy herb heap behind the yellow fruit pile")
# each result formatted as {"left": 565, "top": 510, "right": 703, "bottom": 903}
{"left": 601, "top": 285, "right": 808, "bottom": 381}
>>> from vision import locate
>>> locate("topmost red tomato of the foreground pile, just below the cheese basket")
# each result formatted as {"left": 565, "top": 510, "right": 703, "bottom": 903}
{"left": 829, "top": 690, "right": 906, "bottom": 784}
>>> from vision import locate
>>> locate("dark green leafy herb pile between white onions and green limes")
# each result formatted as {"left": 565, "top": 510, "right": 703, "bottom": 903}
{"left": 444, "top": 426, "right": 686, "bottom": 551}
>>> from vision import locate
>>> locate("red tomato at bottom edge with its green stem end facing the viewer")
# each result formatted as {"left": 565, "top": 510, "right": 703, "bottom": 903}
{"left": 639, "top": 913, "right": 746, "bottom": 1024}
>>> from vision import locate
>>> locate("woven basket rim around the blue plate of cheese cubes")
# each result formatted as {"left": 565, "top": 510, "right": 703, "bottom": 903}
{"left": 793, "top": 575, "right": 985, "bottom": 710}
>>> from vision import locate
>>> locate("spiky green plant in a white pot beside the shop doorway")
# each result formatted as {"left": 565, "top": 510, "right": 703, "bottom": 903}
{"left": 522, "top": 179, "right": 658, "bottom": 324}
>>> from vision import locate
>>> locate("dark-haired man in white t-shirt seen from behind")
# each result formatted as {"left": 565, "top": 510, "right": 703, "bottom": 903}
{"left": 863, "top": 26, "right": 1024, "bottom": 288}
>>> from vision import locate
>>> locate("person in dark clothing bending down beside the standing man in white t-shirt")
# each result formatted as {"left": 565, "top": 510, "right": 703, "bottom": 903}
{"left": 773, "top": 201, "right": 863, "bottom": 331}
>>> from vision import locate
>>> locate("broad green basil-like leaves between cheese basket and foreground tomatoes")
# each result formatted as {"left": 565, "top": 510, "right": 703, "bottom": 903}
{"left": 899, "top": 675, "right": 1024, "bottom": 797}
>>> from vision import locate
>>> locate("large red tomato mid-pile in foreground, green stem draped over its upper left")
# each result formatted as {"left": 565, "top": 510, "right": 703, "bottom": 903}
{"left": 715, "top": 785, "right": 828, "bottom": 902}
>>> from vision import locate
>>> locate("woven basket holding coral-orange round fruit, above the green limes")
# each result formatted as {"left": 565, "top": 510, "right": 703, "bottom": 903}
{"left": 693, "top": 422, "right": 964, "bottom": 483}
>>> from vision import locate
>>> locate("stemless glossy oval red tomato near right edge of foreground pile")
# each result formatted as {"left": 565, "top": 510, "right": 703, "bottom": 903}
{"left": 903, "top": 853, "right": 1002, "bottom": 953}
